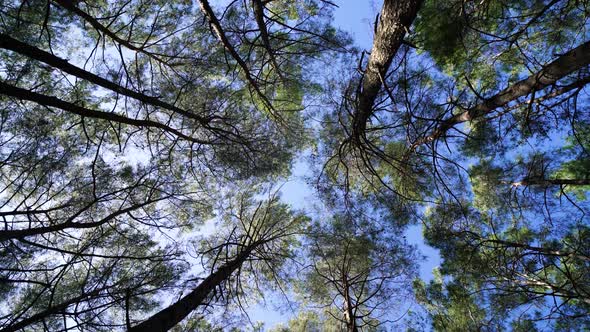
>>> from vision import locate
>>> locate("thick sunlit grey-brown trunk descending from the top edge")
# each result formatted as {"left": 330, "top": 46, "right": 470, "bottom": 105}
{"left": 352, "top": 0, "right": 422, "bottom": 145}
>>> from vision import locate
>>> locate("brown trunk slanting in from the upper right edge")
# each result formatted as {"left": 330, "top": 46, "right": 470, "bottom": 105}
{"left": 410, "top": 42, "right": 590, "bottom": 150}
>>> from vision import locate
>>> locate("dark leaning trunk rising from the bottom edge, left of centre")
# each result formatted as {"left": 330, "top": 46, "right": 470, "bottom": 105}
{"left": 129, "top": 248, "right": 260, "bottom": 332}
